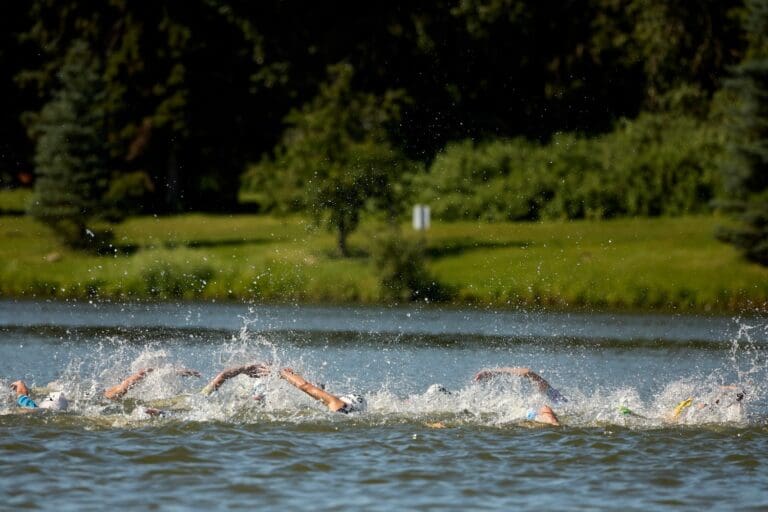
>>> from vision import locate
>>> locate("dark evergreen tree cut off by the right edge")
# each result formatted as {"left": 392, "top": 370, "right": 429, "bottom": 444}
{"left": 717, "top": 0, "right": 768, "bottom": 265}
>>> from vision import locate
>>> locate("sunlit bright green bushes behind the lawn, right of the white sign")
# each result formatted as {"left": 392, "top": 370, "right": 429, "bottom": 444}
{"left": 414, "top": 114, "right": 722, "bottom": 220}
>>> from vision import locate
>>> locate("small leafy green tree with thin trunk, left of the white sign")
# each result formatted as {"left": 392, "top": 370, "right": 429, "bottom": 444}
{"left": 252, "top": 63, "right": 416, "bottom": 256}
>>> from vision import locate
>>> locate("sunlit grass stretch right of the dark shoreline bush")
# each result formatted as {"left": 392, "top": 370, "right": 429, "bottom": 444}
{"left": 424, "top": 217, "right": 768, "bottom": 311}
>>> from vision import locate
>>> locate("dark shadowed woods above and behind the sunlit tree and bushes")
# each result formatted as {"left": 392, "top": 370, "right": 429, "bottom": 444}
{"left": 0, "top": 0, "right": 744, "bottom": 184}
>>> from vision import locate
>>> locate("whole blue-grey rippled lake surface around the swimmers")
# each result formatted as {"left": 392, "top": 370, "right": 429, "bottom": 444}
{"left": 0, "top": 302, "right": 768, "bottom": 510}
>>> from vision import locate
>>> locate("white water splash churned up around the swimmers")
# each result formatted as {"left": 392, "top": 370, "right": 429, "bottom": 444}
{"left": 0, "top": 314, "right": 768, "bottom": 428}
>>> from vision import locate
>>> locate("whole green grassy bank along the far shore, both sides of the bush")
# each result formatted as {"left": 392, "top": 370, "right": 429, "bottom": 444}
{"left": 0, "top": 214, "right": 768, "bottom": 311}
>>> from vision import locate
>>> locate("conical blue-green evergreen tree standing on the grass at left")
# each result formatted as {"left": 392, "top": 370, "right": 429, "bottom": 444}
{"left": 29, "top": 40, "right": 108, "bottom": 247}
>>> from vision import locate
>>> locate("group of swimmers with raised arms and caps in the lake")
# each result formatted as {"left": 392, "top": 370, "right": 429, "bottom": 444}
{"left": 11, "top": 362, "right": 745, "bottom": 426}
